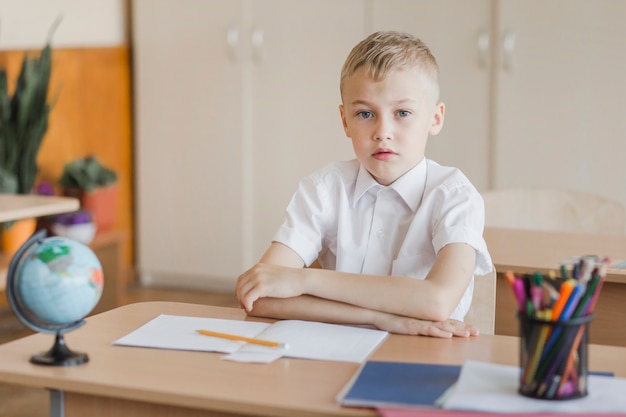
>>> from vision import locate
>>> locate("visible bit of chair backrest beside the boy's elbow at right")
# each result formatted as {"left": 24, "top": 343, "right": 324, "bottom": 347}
{"left": 464, "top": 267, "right": 496, "bottom": 334}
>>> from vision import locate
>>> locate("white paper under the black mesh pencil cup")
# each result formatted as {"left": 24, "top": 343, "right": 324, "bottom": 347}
{"left": 443, "top": 361, "right": 626, "bottom": 413}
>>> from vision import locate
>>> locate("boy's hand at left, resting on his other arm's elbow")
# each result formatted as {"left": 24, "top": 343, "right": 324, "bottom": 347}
{"left": 235, "top": 263, "right": 302, "bottom": 312}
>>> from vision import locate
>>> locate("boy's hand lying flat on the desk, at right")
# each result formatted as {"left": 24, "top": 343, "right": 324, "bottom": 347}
{"left": 376, "top": 313, "right": 479, "bottom": 338}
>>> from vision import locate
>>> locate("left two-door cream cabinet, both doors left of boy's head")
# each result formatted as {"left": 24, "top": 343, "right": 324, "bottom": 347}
{"left": 132, "top": 0, "right": 365, "bottom": 288}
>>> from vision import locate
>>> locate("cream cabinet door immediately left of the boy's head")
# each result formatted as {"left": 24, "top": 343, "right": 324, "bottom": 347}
{"left": 244, "top": 0, "right": 365, "bottom": 264}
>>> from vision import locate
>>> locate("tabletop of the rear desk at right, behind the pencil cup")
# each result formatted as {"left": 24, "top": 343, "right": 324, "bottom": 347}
{"left": 484, "top": 227, "right": 626, "bottom": 283}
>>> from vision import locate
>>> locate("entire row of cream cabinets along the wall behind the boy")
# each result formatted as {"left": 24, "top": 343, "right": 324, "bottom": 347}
{"left": 132, "top": 0, "right": 626, "bottom": 286}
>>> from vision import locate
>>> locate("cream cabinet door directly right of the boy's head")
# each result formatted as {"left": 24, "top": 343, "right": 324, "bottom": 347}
{"left": 370, "top": 0, "right": 491, "bottom": 190}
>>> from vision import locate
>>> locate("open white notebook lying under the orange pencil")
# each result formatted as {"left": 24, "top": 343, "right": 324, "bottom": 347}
{"left": 113, "top": 315, "right": 388, "bottom": 363}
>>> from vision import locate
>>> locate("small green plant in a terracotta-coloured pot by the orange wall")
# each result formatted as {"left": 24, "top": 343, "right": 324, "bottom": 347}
{"left": 59, "top": 155, "right": 117, "bottom": 231}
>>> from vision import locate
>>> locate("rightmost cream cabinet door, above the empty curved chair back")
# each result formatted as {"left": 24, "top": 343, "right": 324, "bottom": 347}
{"left": 495, "top": 0, "right": 626, "bottom": 204}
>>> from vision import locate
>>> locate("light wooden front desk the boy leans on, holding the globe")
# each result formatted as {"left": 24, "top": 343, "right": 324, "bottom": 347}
{"left": 0, "top": 302, "right": 626, "bottom": 417}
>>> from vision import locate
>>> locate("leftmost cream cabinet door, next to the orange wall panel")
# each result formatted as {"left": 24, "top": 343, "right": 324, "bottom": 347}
{"left": 132, "top": 0, "right": 242, "bottom": 283}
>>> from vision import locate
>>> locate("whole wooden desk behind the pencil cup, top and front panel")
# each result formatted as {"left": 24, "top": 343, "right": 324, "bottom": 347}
{"left": 484, "top": 228, "right": 626, "bottom": 346}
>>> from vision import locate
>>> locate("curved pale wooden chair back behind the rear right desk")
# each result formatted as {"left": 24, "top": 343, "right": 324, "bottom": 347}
{"left": 482, "top": 188, "right": 626, "bottom": 236}
